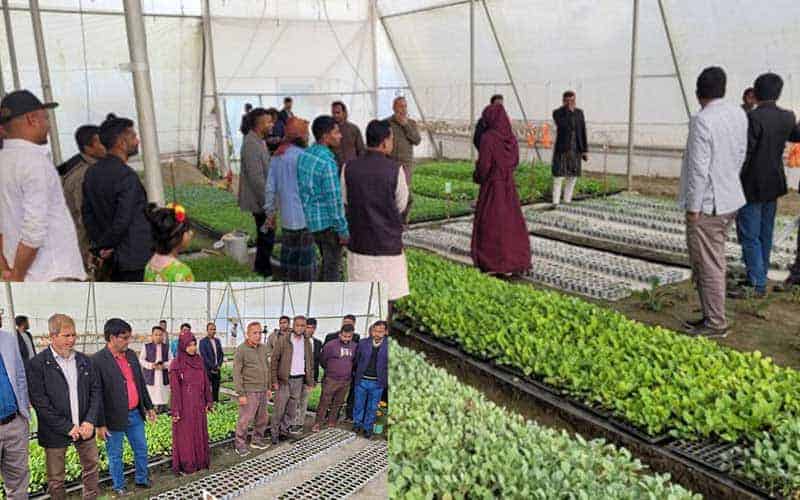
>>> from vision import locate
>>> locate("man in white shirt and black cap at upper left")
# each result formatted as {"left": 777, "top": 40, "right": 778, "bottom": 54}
{"left": 0, "top": 90, "right": 86, "bottom": 281}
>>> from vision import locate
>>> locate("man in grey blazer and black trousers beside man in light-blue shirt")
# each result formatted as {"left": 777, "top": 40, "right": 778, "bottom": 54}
{"left": 239, "top": 108, "right": 275, "bottom": 278}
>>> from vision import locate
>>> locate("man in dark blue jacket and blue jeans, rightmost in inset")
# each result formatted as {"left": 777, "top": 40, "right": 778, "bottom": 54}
{"left": 353, "top": 321, "right": 389, "bottom": 439}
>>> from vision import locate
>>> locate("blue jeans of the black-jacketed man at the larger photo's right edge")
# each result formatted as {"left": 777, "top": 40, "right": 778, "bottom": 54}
{"left": 736, "top": 201, "right": 777, "bottom": 292}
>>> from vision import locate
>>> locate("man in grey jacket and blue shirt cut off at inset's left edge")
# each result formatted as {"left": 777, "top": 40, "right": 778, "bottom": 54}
{"left": 0, "top": 330, "right": 31, "bottom": 500}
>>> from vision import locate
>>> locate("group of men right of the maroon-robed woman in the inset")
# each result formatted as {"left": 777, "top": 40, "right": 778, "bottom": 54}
{"left": 233, "top": 315, "right": 389, "bottom": 456}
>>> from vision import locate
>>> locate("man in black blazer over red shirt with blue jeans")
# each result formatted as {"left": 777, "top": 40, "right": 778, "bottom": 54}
{"left": 92, "top": 318, "right": 156, "bottom": 496}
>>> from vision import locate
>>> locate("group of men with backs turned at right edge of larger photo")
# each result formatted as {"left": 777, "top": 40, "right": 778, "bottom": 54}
{"left": 679, "top": 67, "right": 800, "bottom": 337}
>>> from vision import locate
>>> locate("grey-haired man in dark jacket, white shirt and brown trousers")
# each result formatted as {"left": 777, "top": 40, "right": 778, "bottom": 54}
{"left": 28, "top": 314, "right": 102, "bottom": 498}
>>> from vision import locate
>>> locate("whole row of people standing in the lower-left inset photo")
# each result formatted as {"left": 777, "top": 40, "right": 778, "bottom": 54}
{"left": 0, "top": 314, "right": 389, "bottom": 499}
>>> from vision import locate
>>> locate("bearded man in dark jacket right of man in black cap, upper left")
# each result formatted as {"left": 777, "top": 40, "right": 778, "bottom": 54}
{"left": 83, "top": 114, "right": 153, "bottom": 281}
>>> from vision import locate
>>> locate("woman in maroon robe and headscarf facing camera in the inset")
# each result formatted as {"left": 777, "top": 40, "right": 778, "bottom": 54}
{"left": 169, "top": 333, "right": 214, "bottom": 474}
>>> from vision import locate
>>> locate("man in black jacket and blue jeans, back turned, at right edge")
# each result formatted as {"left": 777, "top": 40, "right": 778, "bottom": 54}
{"left": 728, "top": 73, "right": 800, "bottom": 298}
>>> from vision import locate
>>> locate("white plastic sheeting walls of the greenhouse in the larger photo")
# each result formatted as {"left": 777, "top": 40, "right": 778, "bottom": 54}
{"left": 0, "top": 0, "right": 800, "bottom": 173}
